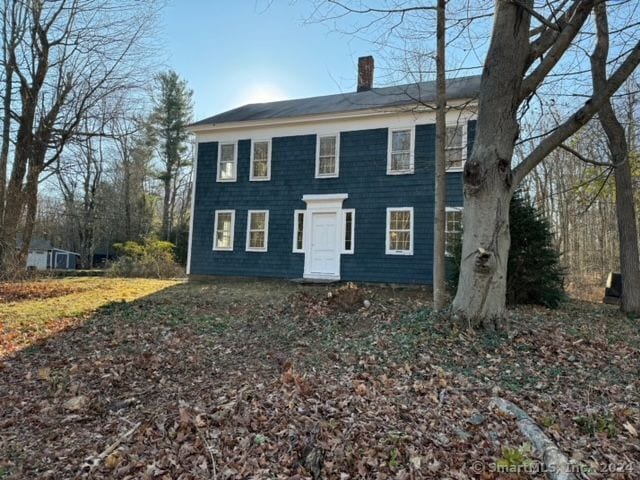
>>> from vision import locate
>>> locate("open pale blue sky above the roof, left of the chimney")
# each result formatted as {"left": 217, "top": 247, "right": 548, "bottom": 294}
{"left": 161, "top": 0, "right": 372, "bottom": 119}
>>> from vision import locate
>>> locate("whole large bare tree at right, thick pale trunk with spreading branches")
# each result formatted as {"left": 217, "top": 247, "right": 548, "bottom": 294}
{"left": 318, "top": 0, "right": 640, "bottom": 328}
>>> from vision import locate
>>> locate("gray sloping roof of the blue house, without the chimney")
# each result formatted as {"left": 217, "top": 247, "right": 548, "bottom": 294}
{"left": 192, "top": 75, "right": 480, "bottom": 126}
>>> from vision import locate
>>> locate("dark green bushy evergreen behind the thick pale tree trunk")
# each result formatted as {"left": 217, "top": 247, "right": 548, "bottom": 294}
{"left": 450, "top": 193, "right": 566, "bottom": 308}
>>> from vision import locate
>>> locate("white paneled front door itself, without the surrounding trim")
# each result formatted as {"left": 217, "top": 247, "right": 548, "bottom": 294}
{"left": 305, "top": 212, "right": 340, "bottom": 278}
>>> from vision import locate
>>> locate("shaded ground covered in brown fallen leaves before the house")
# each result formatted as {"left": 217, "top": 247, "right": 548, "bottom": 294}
{"left": 0, "top": 279, "right": 640, "bottom": 479}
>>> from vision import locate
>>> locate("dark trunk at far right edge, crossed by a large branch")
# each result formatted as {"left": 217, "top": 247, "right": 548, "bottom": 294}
{"left": 591, "top": 3, "right": 640, "bottom": 314}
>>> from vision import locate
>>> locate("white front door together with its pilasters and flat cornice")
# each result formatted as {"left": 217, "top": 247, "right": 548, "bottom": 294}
{"left": 302, "top": 193, "right": 349, "bottom": 280}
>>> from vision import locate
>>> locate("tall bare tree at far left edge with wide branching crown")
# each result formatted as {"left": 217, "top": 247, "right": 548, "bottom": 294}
{"left": 0, "top": 0, "right": 157, "bottom": 271}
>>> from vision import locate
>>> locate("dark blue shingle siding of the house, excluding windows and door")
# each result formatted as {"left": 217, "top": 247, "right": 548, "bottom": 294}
{"left": 191, "top": 124, "right": 472, "bottom": 284}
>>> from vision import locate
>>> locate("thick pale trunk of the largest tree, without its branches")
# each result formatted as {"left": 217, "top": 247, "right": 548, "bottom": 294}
{"left": 452, "top": 0, "right": 533, "bottom": 328}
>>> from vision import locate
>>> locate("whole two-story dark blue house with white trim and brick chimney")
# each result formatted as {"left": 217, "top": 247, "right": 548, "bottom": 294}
{"left": 187, "top": 57, "right": 480, "bottom": 284}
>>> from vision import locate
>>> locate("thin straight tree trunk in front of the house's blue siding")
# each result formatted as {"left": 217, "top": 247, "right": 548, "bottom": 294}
{"left": 433, "top": 0, "right": 447, "bottom": 311}
